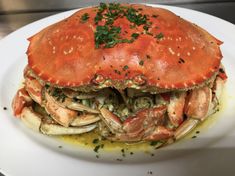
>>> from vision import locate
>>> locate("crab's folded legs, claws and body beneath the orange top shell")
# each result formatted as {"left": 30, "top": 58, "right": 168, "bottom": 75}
{"left": 12, "top": 68, "right": 225, "bottom": 146}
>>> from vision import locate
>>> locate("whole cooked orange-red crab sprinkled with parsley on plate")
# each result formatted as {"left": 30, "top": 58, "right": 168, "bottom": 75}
{"left": 12, "top": 3, "right": 227, "bottom": 146}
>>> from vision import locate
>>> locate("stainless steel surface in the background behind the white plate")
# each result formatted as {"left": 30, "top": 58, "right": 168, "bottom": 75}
{"left": 0, "top": 0, "right": 235, "bottom": 39}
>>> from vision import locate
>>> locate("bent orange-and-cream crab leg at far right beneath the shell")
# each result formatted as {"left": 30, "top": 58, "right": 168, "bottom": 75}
{"left": 174, "top": 76, "right": 225, "bottom": 140}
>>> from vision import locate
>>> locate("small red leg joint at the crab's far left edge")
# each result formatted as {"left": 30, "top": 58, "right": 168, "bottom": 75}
{"left": 12, "top": 88, "right": 33, "bottom": 117}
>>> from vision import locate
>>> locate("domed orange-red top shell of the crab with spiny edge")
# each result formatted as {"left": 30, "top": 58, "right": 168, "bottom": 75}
{"left": 27, "top": 4, "right": 222, "bottom": 89}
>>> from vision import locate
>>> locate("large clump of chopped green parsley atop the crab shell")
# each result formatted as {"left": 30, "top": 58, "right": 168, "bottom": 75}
{"left": 92, "top": 3, "right": 164, "bottom": 48}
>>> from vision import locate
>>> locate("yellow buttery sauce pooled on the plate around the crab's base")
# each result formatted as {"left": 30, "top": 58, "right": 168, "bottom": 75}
{"left": 57, "top": 91, "right": 227, "bottom": 153}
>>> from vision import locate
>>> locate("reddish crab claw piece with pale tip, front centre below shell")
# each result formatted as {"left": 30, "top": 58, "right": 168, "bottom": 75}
{"left": 100, "top": 106, "right": 173, "bottom": 142}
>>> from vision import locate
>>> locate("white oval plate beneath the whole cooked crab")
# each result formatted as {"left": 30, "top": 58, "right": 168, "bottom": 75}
{"left": 0, "top": 3, "right": 235, "bottom": 176}
